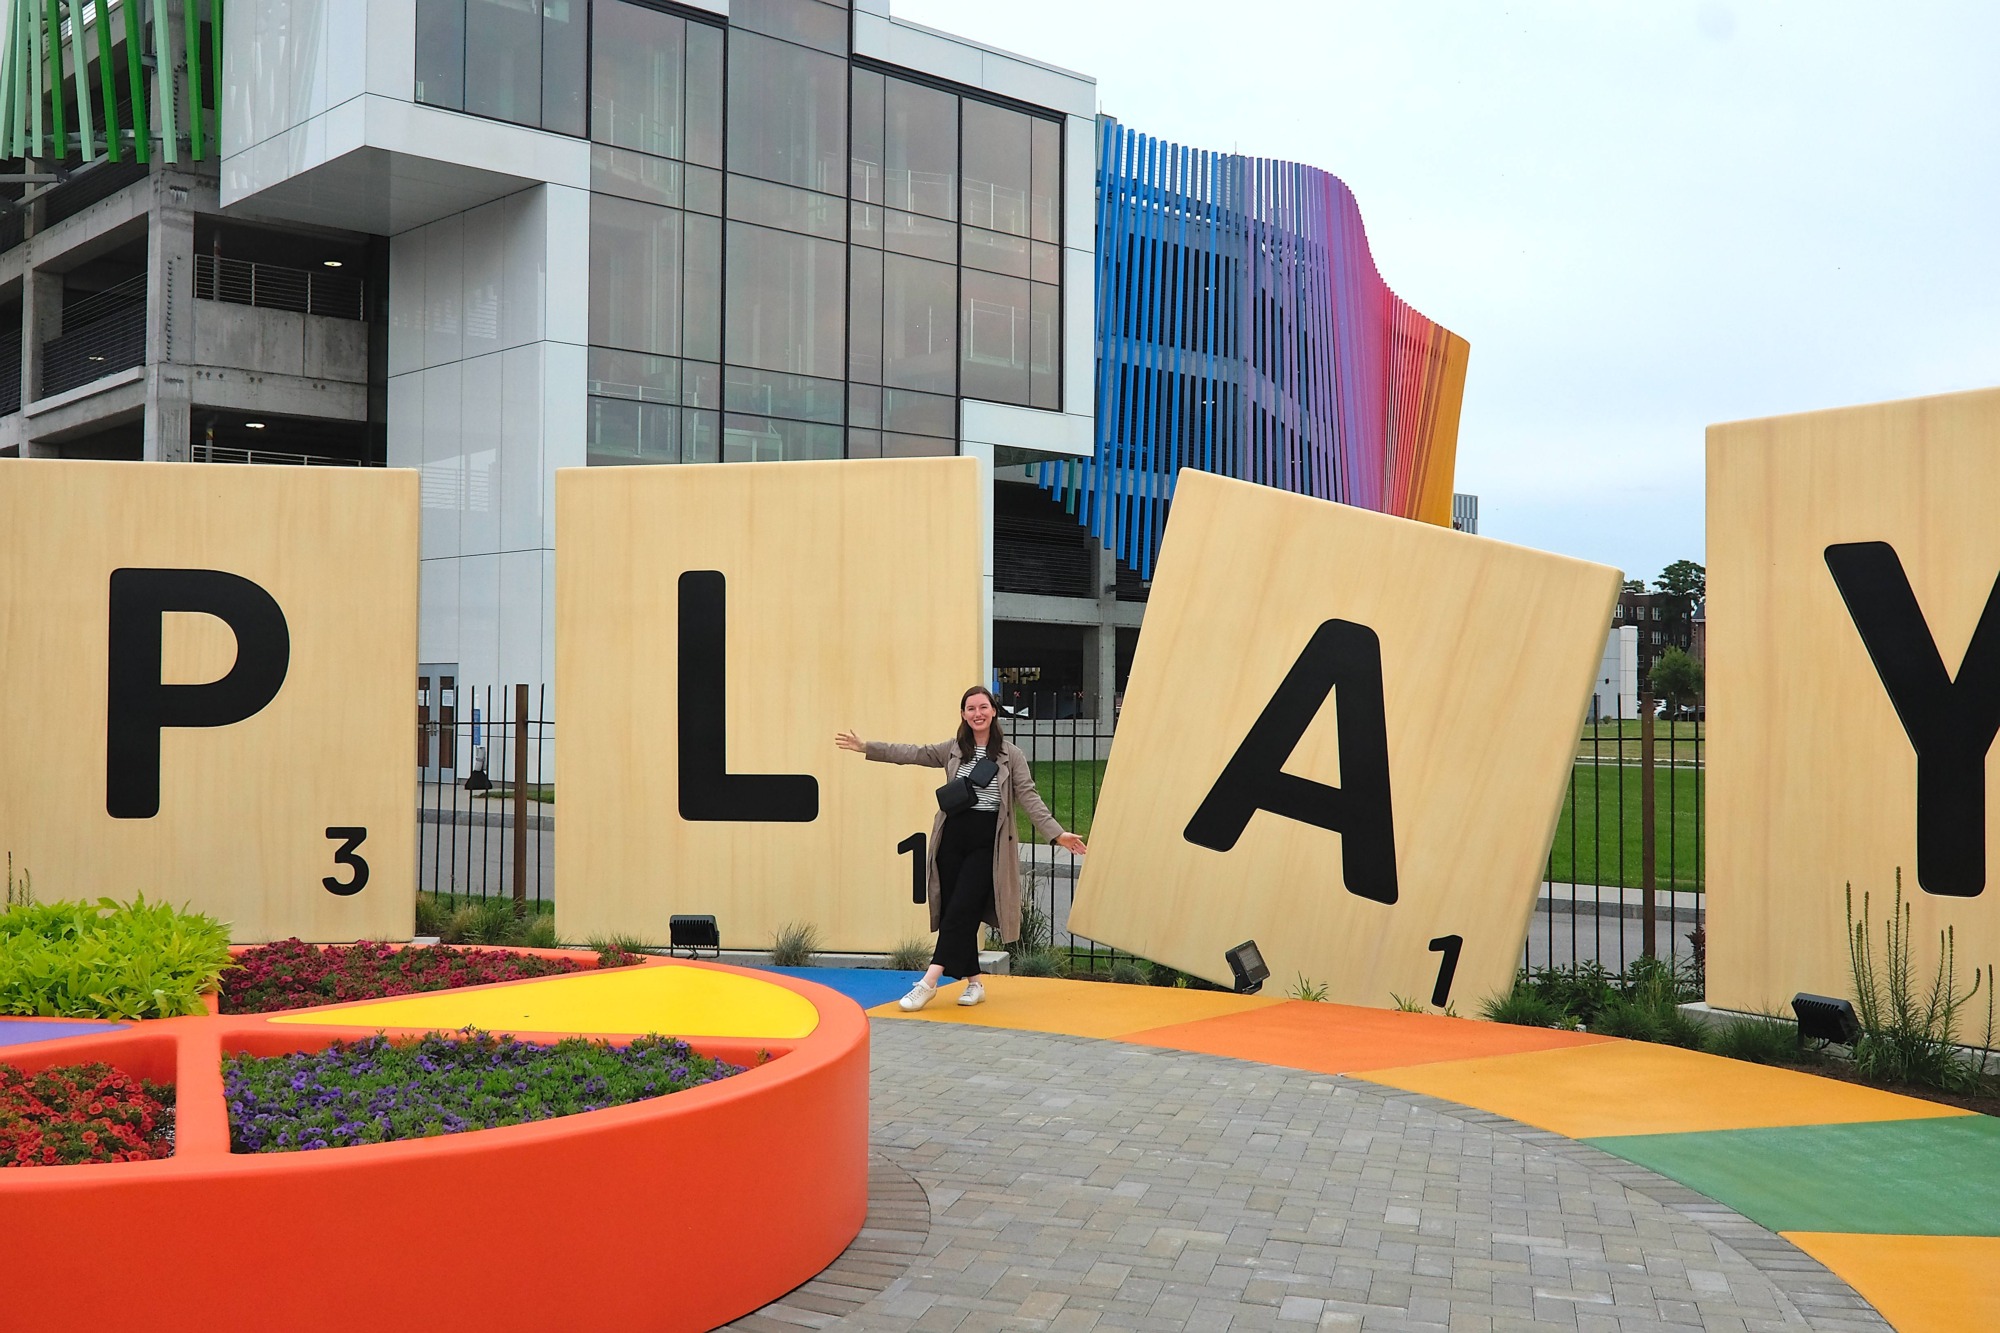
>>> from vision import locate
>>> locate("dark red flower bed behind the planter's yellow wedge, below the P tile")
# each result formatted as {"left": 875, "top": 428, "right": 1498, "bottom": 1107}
{"left": 222, "top": 939, "right": 638, "bottom": 1013}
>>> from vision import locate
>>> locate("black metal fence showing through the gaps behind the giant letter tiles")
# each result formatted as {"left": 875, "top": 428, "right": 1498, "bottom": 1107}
{"left": 418, "top": 687, "right": 1706, "bottom": 979}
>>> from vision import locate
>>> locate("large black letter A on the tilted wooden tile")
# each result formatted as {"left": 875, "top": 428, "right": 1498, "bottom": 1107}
{"left": 1182, "top": 620, "right": 1396, "bottom": 903}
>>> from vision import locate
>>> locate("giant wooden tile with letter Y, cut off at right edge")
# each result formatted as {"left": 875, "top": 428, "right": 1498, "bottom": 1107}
{"left": 1708, "top": 390, "right": 2000, "bottom": 1008}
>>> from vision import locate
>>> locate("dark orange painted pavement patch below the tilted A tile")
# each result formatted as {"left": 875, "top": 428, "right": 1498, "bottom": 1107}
{"left": 1124, "top": 1001, "right": 1612, "bottom": 1073}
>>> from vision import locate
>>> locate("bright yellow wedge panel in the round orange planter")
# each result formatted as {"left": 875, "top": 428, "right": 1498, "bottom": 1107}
{"left": 272, "top": 967, "right": 820, "bottom": 1037}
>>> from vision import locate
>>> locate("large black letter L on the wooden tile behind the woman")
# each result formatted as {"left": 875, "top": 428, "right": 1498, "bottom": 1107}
{"left": 680, "top": 568, "right": 820, "bottom": 825}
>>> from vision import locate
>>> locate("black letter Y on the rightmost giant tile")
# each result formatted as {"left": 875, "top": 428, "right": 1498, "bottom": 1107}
{"left": 1826, "top": 542, "right": 2000, "bottom": 899}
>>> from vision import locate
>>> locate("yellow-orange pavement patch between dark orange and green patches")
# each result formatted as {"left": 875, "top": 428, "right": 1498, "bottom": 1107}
{"left": 1354, "top": 1041, "right": 1970, "bottom": 1139}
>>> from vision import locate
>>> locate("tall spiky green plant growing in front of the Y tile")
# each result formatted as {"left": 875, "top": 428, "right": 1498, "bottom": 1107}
{"left": 1848, "top": 867, "right": 1994, "bottom": 1093}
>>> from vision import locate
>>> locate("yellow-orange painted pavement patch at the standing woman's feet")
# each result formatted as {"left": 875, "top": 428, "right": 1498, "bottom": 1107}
{"left": 868, "top": 977, "right": 1284, "bottom": 1037}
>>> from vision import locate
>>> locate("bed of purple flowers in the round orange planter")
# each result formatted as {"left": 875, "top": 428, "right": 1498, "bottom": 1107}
{"left": 222, "top": 1029, "right": 742, "bottom": 1153}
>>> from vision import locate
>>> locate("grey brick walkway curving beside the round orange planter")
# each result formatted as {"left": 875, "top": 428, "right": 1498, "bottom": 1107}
{"left": 758, "top": 1021, "right": 1888, "bottom": 1333}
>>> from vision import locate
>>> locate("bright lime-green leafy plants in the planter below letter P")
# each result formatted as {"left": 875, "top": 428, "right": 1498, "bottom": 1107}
{"left": 0, "top": 897, "right": 230, "bottom": 1019}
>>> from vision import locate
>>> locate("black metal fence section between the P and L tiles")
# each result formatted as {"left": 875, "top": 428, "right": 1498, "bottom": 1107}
{"left": 416, "top": 683, "right": 556, "bottom": 911}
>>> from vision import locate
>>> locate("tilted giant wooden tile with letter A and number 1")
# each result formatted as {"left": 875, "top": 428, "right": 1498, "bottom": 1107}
{"left": 1070, "top": 470, "right": 1618, "bottom": 1011}
